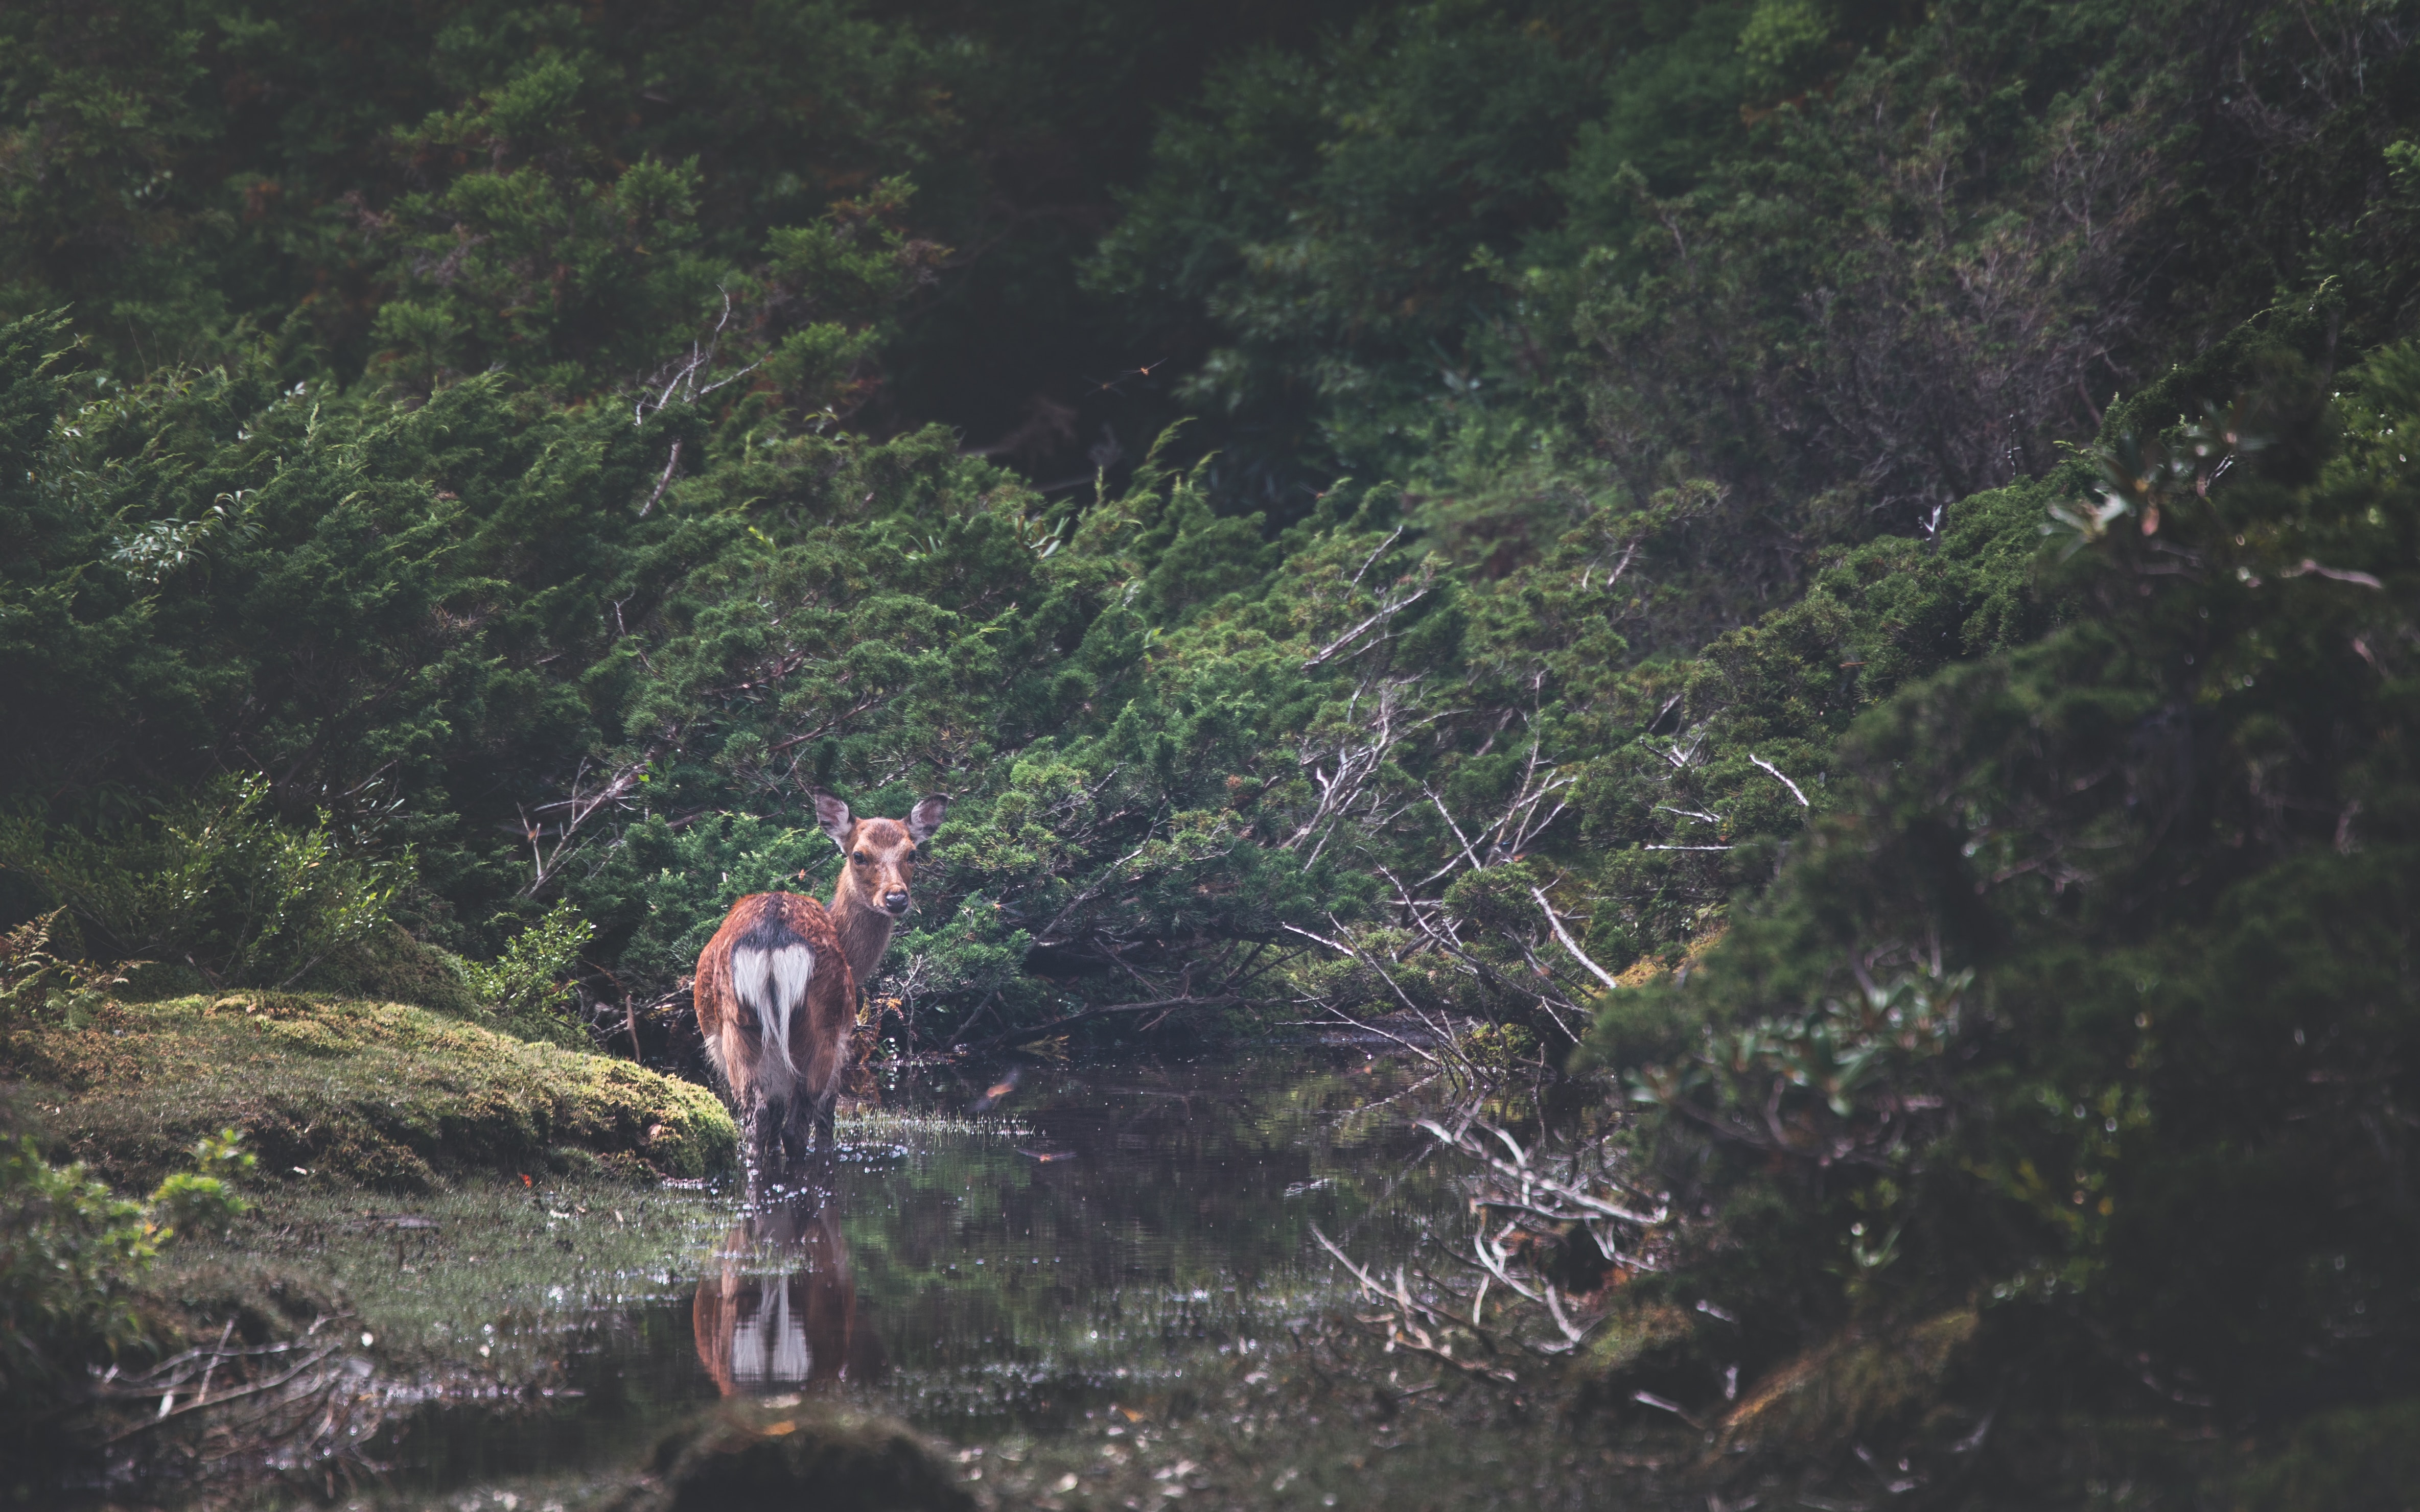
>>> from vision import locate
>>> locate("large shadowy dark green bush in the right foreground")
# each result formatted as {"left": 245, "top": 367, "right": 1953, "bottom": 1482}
{"left": 1595, "top": 341, "right": 2420, "bottom": 1437}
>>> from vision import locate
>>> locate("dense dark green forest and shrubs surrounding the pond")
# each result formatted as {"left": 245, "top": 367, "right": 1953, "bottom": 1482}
{"left": 0, "top": 0, "right": 2420, "bottom": 1505}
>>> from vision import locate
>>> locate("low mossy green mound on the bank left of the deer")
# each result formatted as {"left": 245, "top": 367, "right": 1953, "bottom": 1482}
{"left": 0, "top": 992, "right": 738, "bottom": 1190}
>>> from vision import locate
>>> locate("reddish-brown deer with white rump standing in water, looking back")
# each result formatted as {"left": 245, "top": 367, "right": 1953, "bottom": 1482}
{"left": 694, "top": 789, "right": 949, "bottom": 1200}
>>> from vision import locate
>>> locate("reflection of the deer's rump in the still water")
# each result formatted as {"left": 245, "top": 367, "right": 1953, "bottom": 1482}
{"left": 692, "top": 1193, "right": 886, "bottom": 1396}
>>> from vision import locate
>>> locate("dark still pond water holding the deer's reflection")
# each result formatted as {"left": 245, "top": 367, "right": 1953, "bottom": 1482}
{"left": 382, "top": 1052, "right": 1450, "bottom": 1500}
